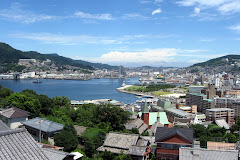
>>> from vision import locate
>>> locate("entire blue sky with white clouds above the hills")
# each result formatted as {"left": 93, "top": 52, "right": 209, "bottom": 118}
{"left": 0, "top": 0, "right": 240, "bottom": 67}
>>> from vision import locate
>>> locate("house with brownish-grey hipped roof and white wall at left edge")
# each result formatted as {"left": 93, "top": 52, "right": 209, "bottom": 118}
{"left": 0, "top": 107, "right": 29, "bottom": 129}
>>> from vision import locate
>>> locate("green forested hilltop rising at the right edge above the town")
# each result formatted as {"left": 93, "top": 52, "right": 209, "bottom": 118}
{"left": 190, "top": 55, "right": 240, "bottom": 67}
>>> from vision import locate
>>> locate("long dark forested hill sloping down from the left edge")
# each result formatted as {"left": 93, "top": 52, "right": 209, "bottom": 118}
{"left": 0, "top": 43, "right": 117, "bottom": 70}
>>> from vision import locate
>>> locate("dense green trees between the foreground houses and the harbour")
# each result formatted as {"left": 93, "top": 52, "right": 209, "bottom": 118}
{"left": 0, "top": 85, "right": 130, "bottom": 159}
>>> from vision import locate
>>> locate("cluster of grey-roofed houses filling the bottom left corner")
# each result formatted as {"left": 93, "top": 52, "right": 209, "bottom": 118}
{"left": 0, "top": 107, "right": 83, "bottom": 160}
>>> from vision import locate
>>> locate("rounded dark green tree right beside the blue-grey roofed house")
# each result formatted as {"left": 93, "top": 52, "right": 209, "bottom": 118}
{"left": 54, "top": 127, "right": 78, "bottom": 152}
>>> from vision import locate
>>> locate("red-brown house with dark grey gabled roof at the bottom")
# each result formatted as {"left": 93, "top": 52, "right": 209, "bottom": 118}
{"left": 155, "top": 127, "right": 193, "bottom": 160}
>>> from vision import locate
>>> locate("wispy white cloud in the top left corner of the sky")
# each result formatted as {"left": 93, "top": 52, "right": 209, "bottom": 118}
{"left": 0, "top": 3, "right": 56, "bottom": 24}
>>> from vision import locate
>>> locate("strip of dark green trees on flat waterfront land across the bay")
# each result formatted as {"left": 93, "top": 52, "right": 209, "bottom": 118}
{"left": 125, "top": 84, "right": 176, "bottom": 92}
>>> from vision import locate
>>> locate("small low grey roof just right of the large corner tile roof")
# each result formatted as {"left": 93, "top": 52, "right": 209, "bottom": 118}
{"left": 42, "top": 148, "right": 74, "bottom": 160}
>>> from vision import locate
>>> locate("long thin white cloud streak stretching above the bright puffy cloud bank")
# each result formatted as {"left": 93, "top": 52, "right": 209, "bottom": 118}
{"left": 10, "top": 33, "right": 176, "bottom": 45}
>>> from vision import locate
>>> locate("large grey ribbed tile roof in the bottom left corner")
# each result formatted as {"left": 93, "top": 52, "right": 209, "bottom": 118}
{"left": 0, "top": 128, "right": 48, "bottom": 160}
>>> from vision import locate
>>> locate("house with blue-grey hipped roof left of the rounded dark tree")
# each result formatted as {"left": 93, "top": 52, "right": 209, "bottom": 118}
{"left": 22, "top": 117, "right": 64, "bottom": 145}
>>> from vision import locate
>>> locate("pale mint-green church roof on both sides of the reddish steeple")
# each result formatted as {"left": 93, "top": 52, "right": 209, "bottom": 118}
{"left": 138, "top": 112, "right": 169, "bottom": 125}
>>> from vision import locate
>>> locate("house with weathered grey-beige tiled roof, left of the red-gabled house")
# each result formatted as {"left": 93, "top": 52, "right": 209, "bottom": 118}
{"left": 97, "top": 132, "right": 150, "bottom": 160}
